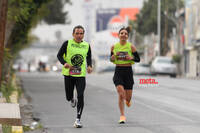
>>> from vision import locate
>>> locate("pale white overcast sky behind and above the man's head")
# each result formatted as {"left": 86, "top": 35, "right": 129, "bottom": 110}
{"left": 32, "top": 0, "right": 143, "bottom": 42}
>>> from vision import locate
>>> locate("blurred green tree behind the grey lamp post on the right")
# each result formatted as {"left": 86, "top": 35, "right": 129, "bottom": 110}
{"left": 135, "top": 0, "right": 183, "bottom": 55}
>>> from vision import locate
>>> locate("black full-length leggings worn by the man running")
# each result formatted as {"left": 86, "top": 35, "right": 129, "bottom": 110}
{"left": 64, "top": 76, "right": 86, "bottom": 119}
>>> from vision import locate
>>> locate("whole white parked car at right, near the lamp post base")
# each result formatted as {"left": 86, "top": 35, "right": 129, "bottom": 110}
{"left": 150, "top": 56, "right": 177, "bottom": 77}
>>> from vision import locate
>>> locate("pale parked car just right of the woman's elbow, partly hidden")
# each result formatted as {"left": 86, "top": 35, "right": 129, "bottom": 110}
{"left": 133, "top": 63, "right": 150, "bottom": 75}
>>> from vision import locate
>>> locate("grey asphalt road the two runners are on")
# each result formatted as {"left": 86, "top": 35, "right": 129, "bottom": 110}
{"left": 18, "top": 73, "right": 200, "bottom": 133}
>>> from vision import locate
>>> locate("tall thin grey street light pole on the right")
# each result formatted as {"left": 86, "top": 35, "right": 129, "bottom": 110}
{"left": 157, "top": 0, "right": 161, "bottom": 56}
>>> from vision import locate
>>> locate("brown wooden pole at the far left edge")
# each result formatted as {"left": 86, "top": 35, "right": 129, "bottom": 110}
{"left": 0, "top": 0, "right": 8, "bottom": 85}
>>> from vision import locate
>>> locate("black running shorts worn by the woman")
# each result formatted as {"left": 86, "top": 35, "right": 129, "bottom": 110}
{"left": 113, "top": 66, "right": 134, "bottom": 90}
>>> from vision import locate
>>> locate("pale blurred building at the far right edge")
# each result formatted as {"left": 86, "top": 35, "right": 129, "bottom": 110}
{"left": 184, "top": 0, "right": 200, "bottom": 77}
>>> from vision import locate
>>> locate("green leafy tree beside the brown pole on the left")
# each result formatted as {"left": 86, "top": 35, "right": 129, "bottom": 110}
{"left": 0, "top": 0, "right": 70, "bottom": 100}
